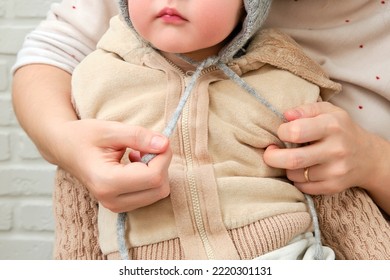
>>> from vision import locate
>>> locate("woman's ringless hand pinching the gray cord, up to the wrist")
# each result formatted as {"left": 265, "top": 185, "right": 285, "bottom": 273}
{"left": 55, "top": 119, "right": 172, "bottom": 212}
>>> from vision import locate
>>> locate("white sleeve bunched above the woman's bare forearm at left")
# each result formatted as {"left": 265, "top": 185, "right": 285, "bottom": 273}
{"left": 12, "top": 0, "right": 118, "bottom": 73}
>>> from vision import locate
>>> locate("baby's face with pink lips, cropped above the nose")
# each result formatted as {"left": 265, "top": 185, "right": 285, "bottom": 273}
{"left": 128, "top": 0, "right": 244, "bottom": 60}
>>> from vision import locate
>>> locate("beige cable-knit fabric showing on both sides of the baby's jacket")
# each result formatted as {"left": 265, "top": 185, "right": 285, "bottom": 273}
{"left": 54, "top": 169, "right": 390, "bottom": 260}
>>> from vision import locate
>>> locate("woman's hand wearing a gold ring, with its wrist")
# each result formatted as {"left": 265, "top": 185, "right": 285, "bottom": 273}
{"left": 264, "top": 102, "right": 390, "bottom": 212}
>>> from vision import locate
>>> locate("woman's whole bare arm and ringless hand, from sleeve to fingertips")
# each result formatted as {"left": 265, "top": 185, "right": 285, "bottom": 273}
{"left": 12, "top": 64, "right": 172, "bottom": 212}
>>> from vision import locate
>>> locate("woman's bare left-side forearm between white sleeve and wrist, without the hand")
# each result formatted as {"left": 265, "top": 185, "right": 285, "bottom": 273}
{"left": 12, "top": 64, "right": 77, "bottom": 164}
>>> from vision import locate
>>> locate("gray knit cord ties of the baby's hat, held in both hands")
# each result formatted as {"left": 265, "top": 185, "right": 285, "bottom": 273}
{"left": 117, "top": 55, "right": 324, "bottom": 260}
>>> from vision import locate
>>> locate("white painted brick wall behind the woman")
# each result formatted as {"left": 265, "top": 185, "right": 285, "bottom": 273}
{"left": 0, "top": 0, "right": 60, "bottom": 260}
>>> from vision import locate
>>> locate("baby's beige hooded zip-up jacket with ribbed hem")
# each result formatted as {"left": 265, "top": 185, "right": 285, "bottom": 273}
{"left": 68, "top": 17, "right": 340, "bottom": 259}
